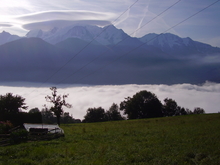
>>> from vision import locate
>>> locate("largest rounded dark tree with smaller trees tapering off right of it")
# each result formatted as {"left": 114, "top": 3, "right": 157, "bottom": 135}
{"left": 120, "top": 90, "right": 205, "bottom": 119}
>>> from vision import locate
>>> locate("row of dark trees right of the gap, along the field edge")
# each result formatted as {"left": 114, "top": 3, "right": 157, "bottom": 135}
{"left": 83, "top": 90, "right": 205, "bottom": 122}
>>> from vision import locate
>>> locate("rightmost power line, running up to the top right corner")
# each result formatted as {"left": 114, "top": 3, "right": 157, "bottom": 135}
{"left": 69, "top": 0, "right": 220, "bottom": 82}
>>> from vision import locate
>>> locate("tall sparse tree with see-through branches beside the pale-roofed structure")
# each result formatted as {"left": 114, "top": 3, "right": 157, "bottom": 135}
{"left": 45, "top": 87, "right": 72, "bottom": 125}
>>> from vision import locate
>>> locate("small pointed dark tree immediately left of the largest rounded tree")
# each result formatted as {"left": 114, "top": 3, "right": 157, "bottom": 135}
{"left": 105, "top": 103, "right": 123, "bottom": 121}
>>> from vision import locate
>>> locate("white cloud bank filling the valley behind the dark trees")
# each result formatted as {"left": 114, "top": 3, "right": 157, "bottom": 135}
{"left": 0, "top": 82, "right": 220, "bottom": 119}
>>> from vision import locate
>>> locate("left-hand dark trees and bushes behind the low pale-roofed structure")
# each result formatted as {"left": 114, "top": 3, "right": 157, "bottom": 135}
{"left": 0, "top": 91, "right": 81, "bottom": 126}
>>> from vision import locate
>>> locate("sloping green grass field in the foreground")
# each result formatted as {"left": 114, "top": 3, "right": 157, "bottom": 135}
{"left": 0, "top": 114, "right": 220, "bottom": 165}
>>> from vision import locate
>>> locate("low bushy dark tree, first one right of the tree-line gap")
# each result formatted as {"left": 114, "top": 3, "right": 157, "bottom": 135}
{"left": 83, "top": 107, "right": 106, "bottom": 123}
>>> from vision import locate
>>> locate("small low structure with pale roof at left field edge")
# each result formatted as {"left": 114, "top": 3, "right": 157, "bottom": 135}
{"left": 24, "top": 123, "right": 64, "bottom": 134}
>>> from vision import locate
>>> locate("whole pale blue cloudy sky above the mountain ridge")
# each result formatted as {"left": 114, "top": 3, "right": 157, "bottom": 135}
{"left": 0, "top": 0, "right": 220, "bottom": 47}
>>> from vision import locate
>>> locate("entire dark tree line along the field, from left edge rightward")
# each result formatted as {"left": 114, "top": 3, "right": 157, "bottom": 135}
{"left": 0, "top": 87, "right": 205, "bottom": 125}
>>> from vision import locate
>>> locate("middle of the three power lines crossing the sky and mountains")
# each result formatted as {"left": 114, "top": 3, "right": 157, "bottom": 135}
{"left": 57, "top": 0, "right": 181, "bottom": 84}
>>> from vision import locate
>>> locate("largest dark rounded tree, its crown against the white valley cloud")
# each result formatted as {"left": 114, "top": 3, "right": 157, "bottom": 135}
{"left": 120, "top": 90, "right": 162, "bottom": 119}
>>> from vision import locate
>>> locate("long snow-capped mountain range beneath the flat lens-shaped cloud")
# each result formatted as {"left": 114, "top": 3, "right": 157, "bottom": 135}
{"left": 26, "top": 25, "right": 220, "bottom": 56}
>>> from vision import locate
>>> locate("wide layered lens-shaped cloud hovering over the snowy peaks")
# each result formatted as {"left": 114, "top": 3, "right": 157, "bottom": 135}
{"left": 17, "top": 10, "right": 115, "bottom": 30}
